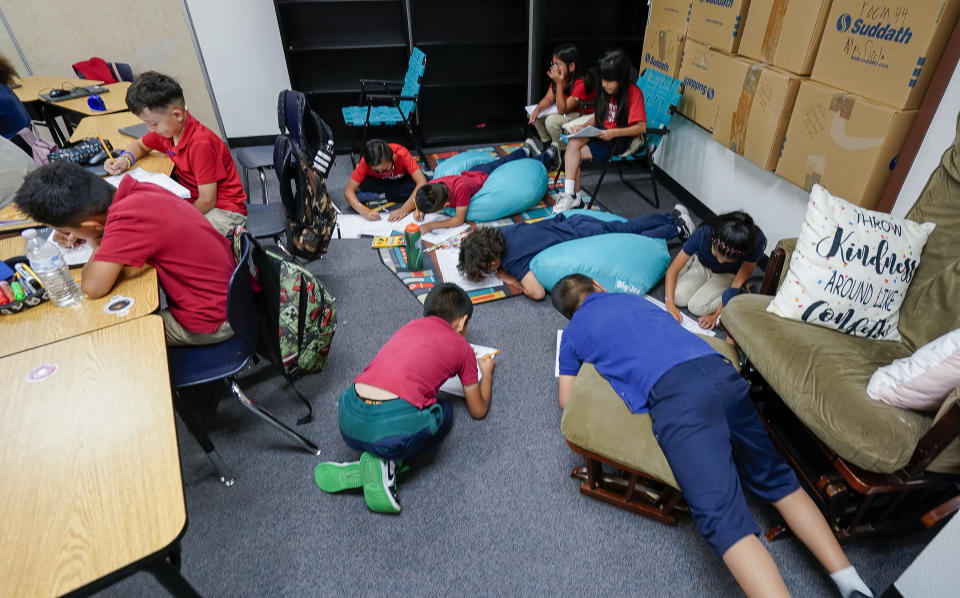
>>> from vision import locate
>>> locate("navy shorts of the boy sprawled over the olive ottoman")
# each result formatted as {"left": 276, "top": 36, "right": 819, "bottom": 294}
{"left": 649, "top": 355, "right": 800, "bottom": 557}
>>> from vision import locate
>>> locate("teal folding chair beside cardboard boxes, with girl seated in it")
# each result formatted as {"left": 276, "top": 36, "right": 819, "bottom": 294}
{"left": 587, "top": 68, "right": 683, "bottom": 209}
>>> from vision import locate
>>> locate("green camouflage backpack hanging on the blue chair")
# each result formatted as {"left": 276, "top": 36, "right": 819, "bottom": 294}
{"left": 233, "top": 227, "right": 337, "bottom": 423}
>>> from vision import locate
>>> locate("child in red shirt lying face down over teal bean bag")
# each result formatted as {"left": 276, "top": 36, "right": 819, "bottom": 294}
{"left": 414, "top": 140, "right": 560, "bottom": 233}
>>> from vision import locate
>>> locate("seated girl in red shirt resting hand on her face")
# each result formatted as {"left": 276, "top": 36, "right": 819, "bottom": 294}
{"left": 528, "top": 44, "right": 597, "bottom": 149}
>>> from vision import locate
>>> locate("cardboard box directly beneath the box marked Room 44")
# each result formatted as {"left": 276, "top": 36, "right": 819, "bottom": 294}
{"left": 777, "top": 81, "right": 917, "bottom": 209}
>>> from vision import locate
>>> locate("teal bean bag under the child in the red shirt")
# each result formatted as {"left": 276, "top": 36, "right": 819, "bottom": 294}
{"left": 445, "top": 158, "right": 547, "bottom": 222}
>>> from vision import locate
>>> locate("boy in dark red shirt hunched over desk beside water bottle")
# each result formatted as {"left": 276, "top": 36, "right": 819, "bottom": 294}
{"left": 14, "top": 162, "right": 234, "bottom": 345}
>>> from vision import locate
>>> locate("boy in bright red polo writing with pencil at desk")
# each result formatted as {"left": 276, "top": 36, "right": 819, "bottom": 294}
{"left": 104, "top": 71, "right": 247, "bottom": 236}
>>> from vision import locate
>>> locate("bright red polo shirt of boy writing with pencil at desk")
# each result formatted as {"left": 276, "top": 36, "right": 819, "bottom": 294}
{"left": 140, "top": 112, "right": 247, "bottom": 215}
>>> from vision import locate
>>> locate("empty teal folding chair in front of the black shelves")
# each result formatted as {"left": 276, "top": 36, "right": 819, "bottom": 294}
{"left": 342, "top": 48, "right": 427, "bottom": 165}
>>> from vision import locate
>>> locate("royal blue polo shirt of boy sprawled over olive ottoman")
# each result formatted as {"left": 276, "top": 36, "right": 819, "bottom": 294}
{"left": 560, "top": 293, "right": 716, "bottom": 413}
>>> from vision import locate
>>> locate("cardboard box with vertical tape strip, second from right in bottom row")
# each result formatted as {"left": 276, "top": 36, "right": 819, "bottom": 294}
{"left": 713, "top": 57, "right": 801, "bottom": 170}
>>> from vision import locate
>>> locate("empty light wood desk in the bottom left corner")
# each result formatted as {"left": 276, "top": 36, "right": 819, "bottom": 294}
{"left": 0, "top": 316, "right": 195, "bottom": 597}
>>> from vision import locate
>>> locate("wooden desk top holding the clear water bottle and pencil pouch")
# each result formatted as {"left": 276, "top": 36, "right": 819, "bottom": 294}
{"left": 0, "top": 237, "right": 160, "bottom": 360}
